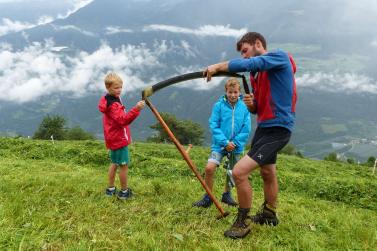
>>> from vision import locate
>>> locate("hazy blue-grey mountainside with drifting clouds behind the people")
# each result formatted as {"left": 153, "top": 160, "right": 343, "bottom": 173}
{"left": 0, "top": 0, "right": 377, "bottom": 159}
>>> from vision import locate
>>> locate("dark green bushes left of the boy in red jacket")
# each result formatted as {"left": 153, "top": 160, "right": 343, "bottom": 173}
{"left": 33, "top": 115, "right": 95, "bottom": 140}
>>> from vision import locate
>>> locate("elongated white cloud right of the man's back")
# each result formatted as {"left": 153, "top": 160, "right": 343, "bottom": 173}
{"left": 296, "top": 72, "right": 377, "bottom": 94}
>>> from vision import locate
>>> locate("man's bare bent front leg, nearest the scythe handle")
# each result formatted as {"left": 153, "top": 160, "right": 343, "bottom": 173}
{"left": 232, "top": 155, "right": 258, "bottom": 208}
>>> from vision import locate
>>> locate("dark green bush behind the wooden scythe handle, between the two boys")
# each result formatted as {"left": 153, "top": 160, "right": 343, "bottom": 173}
{"left": 148, "top": 112, "right": 204, "bottom": 145}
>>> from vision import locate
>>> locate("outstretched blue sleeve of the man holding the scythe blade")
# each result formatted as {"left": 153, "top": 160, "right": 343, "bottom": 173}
{"left": 228, "top": 51, "right": 289, "bottom": 72}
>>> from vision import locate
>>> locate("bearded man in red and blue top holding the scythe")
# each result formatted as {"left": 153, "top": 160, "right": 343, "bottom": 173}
{"left": 204, "top": 32, "right": 297, "bottom": 238}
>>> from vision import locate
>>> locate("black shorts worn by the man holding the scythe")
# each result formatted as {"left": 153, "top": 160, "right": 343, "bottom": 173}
{"left": 247, "top": 126, "right": 291, "bottom": 166}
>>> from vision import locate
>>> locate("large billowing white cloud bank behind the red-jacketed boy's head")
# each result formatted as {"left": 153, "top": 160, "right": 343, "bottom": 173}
{"left": 0, "top": 40, "right": 232, "bottom": 103}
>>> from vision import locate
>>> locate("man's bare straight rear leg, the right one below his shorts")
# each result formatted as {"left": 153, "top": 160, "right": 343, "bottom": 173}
{"left": 260, "top": 164, "right": 279, "bottom": 208}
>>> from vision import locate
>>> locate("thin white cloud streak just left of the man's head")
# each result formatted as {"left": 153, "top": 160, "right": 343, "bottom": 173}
{"left": 143, "top": 24, "right": 247, "bottom": 38}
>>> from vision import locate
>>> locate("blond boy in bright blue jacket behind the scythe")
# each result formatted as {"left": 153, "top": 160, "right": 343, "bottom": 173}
{"left": 193, "top": 78, "right": 251, "bottom": 208}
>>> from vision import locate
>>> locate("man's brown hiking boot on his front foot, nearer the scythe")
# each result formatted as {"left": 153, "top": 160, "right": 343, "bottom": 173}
{"left": 224, "top": 208, "right": 251, "bottom": 239}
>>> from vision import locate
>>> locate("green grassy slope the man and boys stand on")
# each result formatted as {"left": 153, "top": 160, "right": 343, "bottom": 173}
{"left": 0, "top": 138, "right": 377, "bottom": 250}
